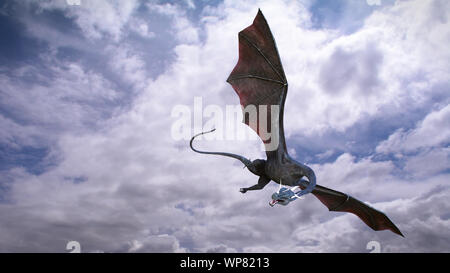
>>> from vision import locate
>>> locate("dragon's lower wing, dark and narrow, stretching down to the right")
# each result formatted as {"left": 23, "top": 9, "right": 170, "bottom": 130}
{"left": 300, "top": 185, "right": 404, "bottom": 237}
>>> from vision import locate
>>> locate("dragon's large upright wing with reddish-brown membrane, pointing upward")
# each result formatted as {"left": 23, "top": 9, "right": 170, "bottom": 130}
{"left": 227, "top": 10, "right": 287, "bottom": 157}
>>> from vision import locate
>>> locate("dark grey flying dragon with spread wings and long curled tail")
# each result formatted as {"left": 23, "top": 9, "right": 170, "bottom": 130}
{"left": 190, "top": 10, "right": 403, "bottom": 236}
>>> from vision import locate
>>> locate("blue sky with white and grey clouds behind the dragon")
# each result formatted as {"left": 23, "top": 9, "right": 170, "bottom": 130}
{"left": 0, "top": 0, "right": 450, "bottom": 252}
